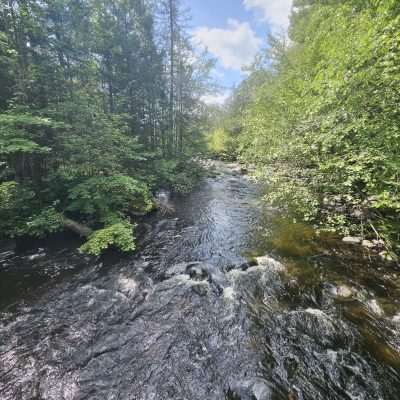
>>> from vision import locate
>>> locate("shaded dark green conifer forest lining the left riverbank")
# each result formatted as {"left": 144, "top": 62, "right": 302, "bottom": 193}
{"left": 0, "top": 0, "right": 212, "bottom": 254}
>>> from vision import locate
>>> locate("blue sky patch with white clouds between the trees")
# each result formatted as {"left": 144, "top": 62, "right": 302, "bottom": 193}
{"left": 182, "top": 0, "right": 292, "bottom": 104}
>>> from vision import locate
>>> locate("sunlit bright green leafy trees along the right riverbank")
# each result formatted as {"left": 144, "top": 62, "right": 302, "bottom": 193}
{"left": 214, "top": 0, "right": 400, "bottom": 252}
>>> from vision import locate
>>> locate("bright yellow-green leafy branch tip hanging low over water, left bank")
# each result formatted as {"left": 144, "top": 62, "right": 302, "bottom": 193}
{"left": 80, "top": 221, "right": 135, "bottom": 256}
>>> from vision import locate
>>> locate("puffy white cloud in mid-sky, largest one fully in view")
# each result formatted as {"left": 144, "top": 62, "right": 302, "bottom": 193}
{"left": 193, "top": 19, "right": 262, "bottom": 70}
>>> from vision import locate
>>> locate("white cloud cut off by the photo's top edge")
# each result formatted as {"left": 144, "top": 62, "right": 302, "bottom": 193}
{"left": 243, "top": 0, "right": 293, "bottom": 29}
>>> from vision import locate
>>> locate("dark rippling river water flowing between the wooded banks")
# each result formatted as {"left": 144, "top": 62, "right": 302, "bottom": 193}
{"left": 0, "top": 161, "right": 400, "bottom": 400}
